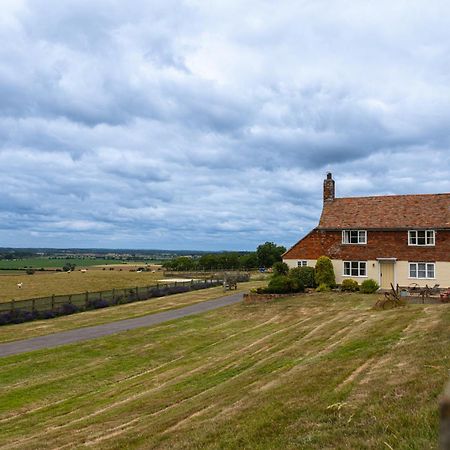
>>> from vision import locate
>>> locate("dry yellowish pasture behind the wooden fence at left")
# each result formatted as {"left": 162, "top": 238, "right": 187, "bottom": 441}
{"left": 0, "top": 269, "right": 163, "bottom": 302}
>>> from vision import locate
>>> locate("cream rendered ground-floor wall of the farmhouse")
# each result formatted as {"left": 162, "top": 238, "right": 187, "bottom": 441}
{"left": 283, "top": 259, "right": 450, "bottom": 288}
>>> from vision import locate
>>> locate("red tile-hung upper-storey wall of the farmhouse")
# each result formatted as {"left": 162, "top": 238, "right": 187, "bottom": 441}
{"left": 284, "top": 229, "right": 450, "bottom": 261}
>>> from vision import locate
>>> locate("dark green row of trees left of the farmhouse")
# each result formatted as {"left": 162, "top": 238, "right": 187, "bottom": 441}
{"left": 163, "top": 242, "right": 286, "bottom": 271}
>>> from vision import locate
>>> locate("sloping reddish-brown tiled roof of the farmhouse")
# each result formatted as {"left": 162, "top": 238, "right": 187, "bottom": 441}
{"left": 319, "top": 193, "right": 450, "bottom": 229}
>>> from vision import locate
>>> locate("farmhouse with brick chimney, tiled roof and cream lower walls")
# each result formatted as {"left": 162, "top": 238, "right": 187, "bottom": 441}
{"left": 283, "top": 173, "right": 450, "bottom": 289}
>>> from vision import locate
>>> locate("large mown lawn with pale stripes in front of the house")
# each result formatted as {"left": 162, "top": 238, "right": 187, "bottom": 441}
{"left": 0, "top": 293, "right": 450, "bottom": 450}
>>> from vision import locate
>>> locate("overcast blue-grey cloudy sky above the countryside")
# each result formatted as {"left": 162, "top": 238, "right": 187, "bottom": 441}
{"left": 0, "top": 0, "right": 450, "bottom": 250}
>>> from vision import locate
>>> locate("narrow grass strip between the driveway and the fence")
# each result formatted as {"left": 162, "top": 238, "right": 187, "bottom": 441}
{"left": 0, "top": 281, "right": 265, "bottom": 342}
